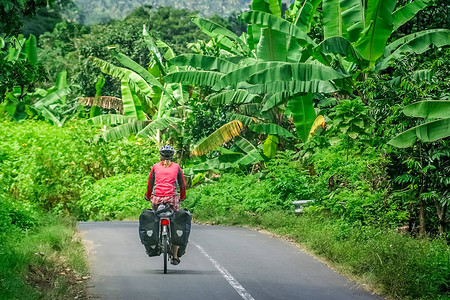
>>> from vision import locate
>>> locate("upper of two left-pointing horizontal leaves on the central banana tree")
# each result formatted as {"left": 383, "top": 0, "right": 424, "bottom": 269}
{"left": 169, "top": 54, "right": 237, "bottom": 73}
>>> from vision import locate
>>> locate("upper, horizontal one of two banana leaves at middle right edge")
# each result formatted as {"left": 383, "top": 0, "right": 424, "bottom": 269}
{"left": 403, "top": 100, "right": 450, "bottom": 119}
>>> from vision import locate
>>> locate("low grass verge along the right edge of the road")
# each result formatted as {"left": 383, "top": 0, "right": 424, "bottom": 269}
{"left": 194, "top": 210, "right": 450, "bottom": 299}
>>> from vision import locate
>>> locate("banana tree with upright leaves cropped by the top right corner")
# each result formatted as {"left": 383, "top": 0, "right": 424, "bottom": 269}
{"left": 315, "top": 0, "right": 450, "bottom": 72}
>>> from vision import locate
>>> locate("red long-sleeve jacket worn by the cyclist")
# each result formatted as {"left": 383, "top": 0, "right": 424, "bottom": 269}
{"left": 145, "top": 162, "right": 186, "bottom": 201}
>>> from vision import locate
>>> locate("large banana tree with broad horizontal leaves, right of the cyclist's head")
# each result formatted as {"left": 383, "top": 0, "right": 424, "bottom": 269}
{"left": 166, "top": 1, "right": 344, "bottom": 149}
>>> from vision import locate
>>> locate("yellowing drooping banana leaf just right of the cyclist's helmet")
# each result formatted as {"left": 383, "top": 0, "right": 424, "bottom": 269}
{"left": 191, "top": 120, "right": 244, "bottom": 156}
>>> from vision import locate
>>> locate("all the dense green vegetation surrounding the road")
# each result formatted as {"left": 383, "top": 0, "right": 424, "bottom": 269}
{"left": 0, "top": 0, "right": 450, "bottom": 299}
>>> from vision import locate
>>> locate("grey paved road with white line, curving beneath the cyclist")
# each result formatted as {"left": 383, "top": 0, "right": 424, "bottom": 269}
{"left": 78, "top": 222, "right": 382, "bottom": 300}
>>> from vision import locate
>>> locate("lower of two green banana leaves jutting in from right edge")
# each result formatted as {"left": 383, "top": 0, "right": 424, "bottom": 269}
{"left": 388, "top": 118, "right": 450, "bottom": 148}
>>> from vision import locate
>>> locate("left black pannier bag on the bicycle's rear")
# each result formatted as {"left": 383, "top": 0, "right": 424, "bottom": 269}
{"left": 139, "top": 209, "right": 159, "bottom": 256}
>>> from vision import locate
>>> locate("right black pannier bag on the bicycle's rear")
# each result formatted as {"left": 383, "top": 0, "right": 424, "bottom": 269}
{"left": 171, "top": 209, "right": 192, "bottom": 256}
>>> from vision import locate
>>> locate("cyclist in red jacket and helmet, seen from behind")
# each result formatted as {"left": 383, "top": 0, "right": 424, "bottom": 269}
{"left": 145, "top": 145, "right": 186, "bottom": 265}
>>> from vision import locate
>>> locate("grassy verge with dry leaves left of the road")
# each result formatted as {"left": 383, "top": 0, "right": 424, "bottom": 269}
{"left": 0, "top": 213, "right": 88, "bottom": 299}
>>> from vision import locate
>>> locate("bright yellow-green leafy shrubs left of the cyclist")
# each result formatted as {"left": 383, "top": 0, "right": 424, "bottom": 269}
{"left": 0, "top": 121, "right": 158, "bottom": 210}
